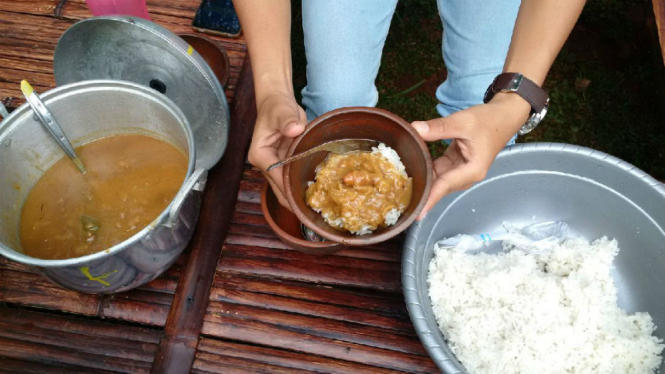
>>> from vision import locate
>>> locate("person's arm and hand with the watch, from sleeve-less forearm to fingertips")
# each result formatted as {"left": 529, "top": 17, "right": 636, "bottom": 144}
{"left": 413, "top": 0, "right": 585, "bottom": 219}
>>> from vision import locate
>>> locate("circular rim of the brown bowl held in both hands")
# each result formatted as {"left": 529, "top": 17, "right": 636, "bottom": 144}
{"left": 283, "top": 106, "right": 434, "bottom": 246}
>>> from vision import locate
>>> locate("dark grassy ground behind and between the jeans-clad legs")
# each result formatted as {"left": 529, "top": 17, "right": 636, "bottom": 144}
{"left": 292, "top": 0, "right": 665, "bottom": 180}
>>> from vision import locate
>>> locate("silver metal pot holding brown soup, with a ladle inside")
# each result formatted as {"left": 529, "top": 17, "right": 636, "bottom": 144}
{"left": 0, "top": 80, "right": 207, "bottom": 293}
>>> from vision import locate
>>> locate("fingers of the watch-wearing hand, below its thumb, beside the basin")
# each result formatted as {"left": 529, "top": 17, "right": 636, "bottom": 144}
{"left": 418, "top": 164, "right": 485, "bottom": 221}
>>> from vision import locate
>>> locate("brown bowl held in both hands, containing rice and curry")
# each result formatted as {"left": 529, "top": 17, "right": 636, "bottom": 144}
{"left": 283, "top": 107, "right": 432, "bottom": 246}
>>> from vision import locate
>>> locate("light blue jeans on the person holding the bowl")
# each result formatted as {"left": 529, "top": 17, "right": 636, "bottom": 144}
{"left": 302, "top": 0, "right": 520, "bottom": 143}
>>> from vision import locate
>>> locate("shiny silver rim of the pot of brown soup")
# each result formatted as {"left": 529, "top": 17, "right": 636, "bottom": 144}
{"left": 0, "top": 79, "right": 196, "bottom": 268}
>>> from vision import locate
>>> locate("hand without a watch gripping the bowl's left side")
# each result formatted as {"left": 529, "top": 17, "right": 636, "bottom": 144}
{"left": 248, "top": 92, "right": 307, "bottom": 209}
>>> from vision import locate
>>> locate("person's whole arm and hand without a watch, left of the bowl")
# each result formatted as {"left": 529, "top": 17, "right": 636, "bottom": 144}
{"left": 233, "top": 0, "right": 307, "bottom": 207}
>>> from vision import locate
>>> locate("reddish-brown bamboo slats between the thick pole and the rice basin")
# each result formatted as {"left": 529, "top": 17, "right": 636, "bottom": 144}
{"left": 194, "top": 166, "right": 436, "bottom": 373}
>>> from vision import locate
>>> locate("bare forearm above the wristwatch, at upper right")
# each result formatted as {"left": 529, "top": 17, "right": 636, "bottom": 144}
{"left": 503, "top": 0, "right": 586, "bottom": 86}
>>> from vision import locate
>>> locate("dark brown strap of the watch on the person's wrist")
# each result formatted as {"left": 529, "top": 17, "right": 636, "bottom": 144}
{"left": 483, "top": 73, "right": 549, "bottom": 113}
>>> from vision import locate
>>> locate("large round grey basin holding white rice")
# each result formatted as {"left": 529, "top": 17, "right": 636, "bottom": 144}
{"left": 402, "top": 143, "right": 665, "bottom": 374}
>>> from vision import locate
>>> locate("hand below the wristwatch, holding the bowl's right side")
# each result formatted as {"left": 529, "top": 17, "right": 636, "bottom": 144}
{"left": 412, "top": 93, "right": 531, "bottom": 220}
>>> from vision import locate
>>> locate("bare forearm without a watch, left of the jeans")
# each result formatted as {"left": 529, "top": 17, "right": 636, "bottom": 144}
{"left": 233, "top": 0, "right": 293, "bottom": 103}
